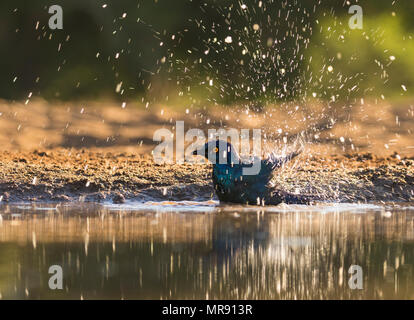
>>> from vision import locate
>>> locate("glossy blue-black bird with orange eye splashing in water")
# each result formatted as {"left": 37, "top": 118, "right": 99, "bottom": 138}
{"left": 192, "top": 139, "right": 311, "bottom": 205}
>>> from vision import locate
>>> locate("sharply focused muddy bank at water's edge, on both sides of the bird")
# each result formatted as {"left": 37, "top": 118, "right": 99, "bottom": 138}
{"left": 0, "top": 149, "right": 414, "bottom": 203}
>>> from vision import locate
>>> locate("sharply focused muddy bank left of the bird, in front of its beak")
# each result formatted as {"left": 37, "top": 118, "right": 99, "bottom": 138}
{"left": 0, "top": 149, "right": 211, "bottom": 202}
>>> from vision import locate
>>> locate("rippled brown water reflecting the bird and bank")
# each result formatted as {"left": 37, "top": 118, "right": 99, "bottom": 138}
{"left": 0, "top": 201, "right": 414, "bottom": 299}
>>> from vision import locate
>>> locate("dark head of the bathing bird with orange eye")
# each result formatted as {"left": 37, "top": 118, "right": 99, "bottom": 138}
{"left": 193, "top": 140, "right": 240, "bottom": 164}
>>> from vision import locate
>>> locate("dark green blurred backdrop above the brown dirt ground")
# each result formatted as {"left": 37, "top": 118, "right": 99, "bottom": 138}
{"left": 0, "top": 0, "right": 414, "bottom": 104}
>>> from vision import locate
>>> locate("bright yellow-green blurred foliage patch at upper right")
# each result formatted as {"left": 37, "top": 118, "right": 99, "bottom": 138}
{"left": 306, "top": 15, "right": 414, "bottom": 100}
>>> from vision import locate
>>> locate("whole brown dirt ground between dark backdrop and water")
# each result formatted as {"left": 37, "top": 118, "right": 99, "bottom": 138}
{"left": 0, "top": 101, "right": 414, "bottom": 202}
